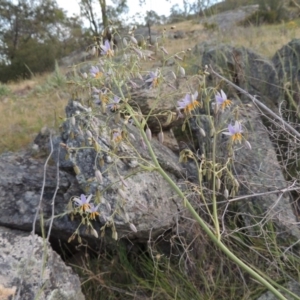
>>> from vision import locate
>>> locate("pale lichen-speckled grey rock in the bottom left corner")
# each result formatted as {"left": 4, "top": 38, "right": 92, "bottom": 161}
{"left": 0, "top": 227, "right": 85, "bottom": 300}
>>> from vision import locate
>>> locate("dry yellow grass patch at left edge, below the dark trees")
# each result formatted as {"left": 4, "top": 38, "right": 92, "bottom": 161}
{"left": 0, "top": 74, "right": 67, "bottom": 153}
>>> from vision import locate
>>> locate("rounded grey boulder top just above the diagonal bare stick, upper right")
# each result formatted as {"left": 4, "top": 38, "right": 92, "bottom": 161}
{"left": 193, "top": 42, "right": 282, "bottom": 110}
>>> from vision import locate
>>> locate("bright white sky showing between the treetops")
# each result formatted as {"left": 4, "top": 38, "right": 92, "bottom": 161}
{"left": 57, "top": 0, "right": 183, "bottom": 16}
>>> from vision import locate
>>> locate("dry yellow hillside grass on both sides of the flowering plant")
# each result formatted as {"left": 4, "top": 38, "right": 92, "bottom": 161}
{"left": 0, "top": 20, "right": 300, "bottom": 153}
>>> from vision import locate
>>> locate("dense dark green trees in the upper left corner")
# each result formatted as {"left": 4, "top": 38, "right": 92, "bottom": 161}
{"left": 0, "top": 0, "right": 83, "bottom": 82}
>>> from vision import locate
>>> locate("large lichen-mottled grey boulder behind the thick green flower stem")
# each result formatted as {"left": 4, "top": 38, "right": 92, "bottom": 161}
{"left": 0, "top": 100, "right": 188, "bottom": 242}
